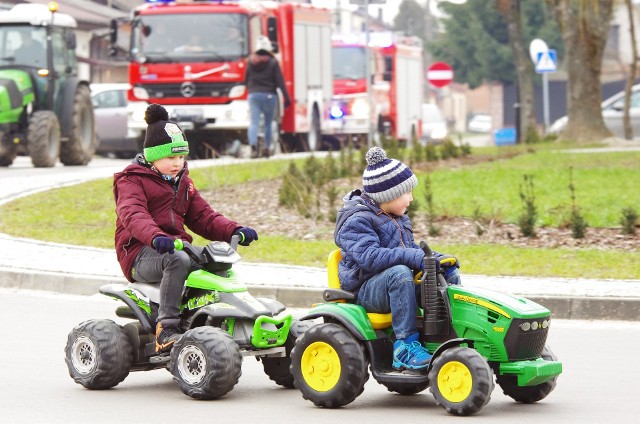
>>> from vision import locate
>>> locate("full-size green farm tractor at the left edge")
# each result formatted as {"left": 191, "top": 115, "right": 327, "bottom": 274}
{"left": 0, "top": 3, "right": 97, "bottom": 167}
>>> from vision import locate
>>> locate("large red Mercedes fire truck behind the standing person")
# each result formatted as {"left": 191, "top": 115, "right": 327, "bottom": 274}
{"left": 111, "top": 0, "right": 333, "bottom": 158}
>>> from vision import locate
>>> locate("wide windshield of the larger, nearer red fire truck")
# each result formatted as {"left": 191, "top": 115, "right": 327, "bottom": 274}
{"left": 131, "top": 13, "right": 249, "bottom": 63}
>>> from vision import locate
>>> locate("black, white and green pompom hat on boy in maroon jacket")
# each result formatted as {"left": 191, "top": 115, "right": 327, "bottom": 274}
{"left": 144, "top": 104, "right": 189, "bottom": 162}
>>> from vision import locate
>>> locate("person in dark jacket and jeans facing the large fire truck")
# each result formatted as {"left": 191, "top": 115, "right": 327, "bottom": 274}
{"left": 247, "top": 36, "right": 291, "bottom": 158}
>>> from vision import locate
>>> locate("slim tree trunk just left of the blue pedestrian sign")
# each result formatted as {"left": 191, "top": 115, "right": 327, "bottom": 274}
{"left": 498, "top": 0, "right": 538, "bottom": 142}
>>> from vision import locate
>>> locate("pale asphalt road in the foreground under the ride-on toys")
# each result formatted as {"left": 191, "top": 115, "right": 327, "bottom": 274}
{"left": 0, "top": 289, "right": 640, "bottom": 424}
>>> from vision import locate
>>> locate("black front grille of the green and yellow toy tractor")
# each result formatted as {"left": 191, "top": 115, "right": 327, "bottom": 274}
{"left": 504, "top": 317, "right": 550, "bottom": 361}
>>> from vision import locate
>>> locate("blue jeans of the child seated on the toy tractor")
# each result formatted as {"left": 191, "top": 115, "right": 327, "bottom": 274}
{"left": 357, "top": 265, "right": 420, "bottom": 339}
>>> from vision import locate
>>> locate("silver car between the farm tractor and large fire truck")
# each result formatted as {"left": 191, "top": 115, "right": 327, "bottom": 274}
{"left": 91, "top": 83, "right": 137, "bottom": 158}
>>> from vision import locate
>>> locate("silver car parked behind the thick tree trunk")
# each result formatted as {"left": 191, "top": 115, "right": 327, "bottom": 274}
{"left": 547, "top": 84, "right": 640, "bottom": 138}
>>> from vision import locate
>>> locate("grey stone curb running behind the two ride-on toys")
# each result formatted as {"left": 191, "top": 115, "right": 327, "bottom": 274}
{"left": 0, "top": 267, "right": 640, "bottom": 321}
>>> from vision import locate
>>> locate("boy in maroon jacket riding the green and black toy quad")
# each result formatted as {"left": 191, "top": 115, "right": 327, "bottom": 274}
{"left": 113, "top": 104, "right": 258, "bottom": 352}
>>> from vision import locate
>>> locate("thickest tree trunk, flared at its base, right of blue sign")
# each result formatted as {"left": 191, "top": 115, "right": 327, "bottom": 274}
{"left": 549, "top": 0, "right": 614, "bottom": 143}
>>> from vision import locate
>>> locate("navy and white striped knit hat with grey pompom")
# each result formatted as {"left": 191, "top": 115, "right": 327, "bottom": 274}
{"left": 362, "top": 147, "right": 418, "bottom": 204}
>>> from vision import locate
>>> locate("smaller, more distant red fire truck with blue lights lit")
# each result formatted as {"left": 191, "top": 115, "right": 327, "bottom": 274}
{"left": 330, "top": 32, "right": 424, "bottom": 143}
